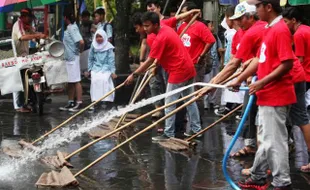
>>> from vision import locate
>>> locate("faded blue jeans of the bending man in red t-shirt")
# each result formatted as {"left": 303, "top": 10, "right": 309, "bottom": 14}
{"left": 164, "top": 79, "right": 201, "bottom": 137}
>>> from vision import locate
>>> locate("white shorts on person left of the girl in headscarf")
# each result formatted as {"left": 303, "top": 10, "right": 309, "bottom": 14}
{"left": 66, "top": 55, "right": 81, "bottom": 83}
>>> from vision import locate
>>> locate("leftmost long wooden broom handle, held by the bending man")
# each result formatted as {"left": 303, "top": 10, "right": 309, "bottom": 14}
{"left": 31, "top": 82, "right": 125, "bottom": 145}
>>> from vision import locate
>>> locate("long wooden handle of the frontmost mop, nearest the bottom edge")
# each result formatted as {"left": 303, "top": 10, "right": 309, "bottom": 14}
{"left": 74, "top": 93, "right": 200, "bottom": 177}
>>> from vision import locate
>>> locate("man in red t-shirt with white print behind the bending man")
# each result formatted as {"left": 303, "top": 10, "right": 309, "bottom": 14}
{"left": 177, "top": 1, "right": 215, "bottom": 82}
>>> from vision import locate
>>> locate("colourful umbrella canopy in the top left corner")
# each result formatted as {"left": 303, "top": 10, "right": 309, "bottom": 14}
{"left": 0, "top": 0, "right": 61, "bottom": 12}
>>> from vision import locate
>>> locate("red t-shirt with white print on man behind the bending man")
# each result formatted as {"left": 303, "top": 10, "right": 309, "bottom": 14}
{"left": 177, "top": 21, "right": 215, "bottom": 64}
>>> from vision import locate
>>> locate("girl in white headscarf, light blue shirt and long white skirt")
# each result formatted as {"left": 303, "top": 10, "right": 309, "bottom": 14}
{"left": 85, "top": 29, "right": 117, "bottom": 109}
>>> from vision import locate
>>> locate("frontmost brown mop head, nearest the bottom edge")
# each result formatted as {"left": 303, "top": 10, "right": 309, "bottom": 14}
{"left": 36, "top": 166, "right": 79, "bottom": 187}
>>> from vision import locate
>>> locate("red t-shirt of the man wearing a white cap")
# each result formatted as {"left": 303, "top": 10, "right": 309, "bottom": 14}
{"left": 235, "top": 21, "right": 267, "bottom": 62}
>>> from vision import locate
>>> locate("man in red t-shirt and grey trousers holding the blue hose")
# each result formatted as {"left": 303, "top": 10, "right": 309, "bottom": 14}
{"left": 230, "top": 0, "right": 296, "bottom": 189}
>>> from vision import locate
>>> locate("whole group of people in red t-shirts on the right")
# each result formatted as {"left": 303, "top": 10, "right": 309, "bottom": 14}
{"left": 126, "top": 0, "right": 310, "bottom": 190}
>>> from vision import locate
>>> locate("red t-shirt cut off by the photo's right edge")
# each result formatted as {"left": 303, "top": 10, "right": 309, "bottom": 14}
{"left": 294, "top": 25, "right": 310, "bottom": 82}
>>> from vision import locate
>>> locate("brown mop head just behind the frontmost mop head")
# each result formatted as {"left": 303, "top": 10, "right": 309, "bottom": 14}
{"left": 41, "top": 151, "right": 73, "bottom": 169}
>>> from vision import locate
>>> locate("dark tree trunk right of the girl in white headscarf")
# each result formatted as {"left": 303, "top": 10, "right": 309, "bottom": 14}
{"left": 114, "top": 0, "right": 133, "bottom": 74}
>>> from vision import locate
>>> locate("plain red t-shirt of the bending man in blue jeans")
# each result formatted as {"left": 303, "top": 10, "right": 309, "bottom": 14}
{"left": 149, "top": 26, "right": 196, "bottom": 84}
